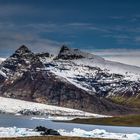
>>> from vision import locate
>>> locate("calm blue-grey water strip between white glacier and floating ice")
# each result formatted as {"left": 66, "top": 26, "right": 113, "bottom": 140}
{"left": 0, "top": 114, "right": 140, "bottom": 134}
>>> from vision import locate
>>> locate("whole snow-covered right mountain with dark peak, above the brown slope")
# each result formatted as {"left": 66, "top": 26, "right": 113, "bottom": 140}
{"left": 44, "top": 46, "right": 140, "bottom": 96}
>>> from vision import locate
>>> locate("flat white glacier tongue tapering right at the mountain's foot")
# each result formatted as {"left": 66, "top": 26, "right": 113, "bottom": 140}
{"left": 0, "top": 97, "right": 106, "bottom": 117}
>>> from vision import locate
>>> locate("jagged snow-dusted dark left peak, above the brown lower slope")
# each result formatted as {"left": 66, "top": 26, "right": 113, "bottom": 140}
{"left": 0, "top": 45, "right": 44, "bottom": 88}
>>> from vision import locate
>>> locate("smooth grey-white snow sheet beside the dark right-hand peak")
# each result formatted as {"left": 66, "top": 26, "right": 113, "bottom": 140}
{"left": 71, "top": 56, "right": 140, "bottom": 80}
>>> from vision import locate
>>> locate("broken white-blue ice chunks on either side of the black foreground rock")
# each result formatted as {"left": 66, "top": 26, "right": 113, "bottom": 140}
{"left": 0, "top": 127, "right": 140, "bottom": 140}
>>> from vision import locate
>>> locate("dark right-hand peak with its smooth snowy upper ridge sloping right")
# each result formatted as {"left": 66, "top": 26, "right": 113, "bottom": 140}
{"left": 57, "top": 46, "right": 140, "bottom": 76}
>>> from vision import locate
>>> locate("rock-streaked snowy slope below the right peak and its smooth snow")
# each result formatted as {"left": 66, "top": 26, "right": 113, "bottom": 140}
{"left": 46, "top": 60, "right": 140, "bottom": 96}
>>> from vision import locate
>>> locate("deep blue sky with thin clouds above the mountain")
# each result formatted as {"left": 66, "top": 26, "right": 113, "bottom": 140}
{"left": 0, "top": 0, "right": 140, "bottom": 66}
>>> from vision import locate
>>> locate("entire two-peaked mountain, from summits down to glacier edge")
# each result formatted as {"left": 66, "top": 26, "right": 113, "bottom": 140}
{"left": 0, "top": 45, "right": 140, "bottom": 114}
